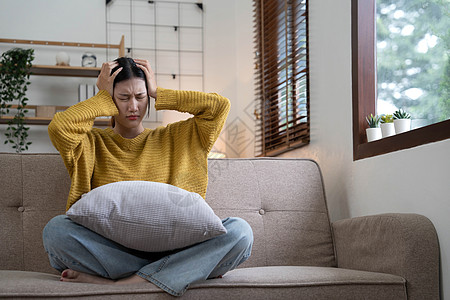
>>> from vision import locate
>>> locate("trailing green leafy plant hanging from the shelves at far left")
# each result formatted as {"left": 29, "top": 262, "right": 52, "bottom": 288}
{"left": 0, "top": 48, "right": 34, "bottom": 153}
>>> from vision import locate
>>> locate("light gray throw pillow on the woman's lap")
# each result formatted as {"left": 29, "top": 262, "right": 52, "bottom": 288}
{"left": 66, "top": 181, "right": 227, "bottom": 252}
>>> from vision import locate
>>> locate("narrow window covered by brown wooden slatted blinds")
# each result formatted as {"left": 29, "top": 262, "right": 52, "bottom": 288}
{"left": 254, "top": 0, "right": 309, "bottom": 156}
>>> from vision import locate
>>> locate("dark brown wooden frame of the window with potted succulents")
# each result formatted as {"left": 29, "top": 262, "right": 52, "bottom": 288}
{"left": 352, "top": 0, "right": 450, "bottom": 160}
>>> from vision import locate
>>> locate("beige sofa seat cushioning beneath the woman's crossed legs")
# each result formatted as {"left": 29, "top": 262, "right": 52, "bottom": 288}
{"left": 0, "top": 266, "right": 406, "bottom": 300}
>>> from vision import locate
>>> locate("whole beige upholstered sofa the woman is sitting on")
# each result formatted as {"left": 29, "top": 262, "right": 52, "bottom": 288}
{"left": 0, "top": 153, "right": 439, "bottom": 300}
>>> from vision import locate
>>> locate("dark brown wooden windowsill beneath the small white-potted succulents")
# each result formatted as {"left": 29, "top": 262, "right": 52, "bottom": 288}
{"left": 353, "top": 120, "right": 450, "bottom": 160}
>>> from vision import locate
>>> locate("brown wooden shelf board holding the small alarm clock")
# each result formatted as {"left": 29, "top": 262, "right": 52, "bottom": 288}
{"left": 31, "top": 65, "right": 100, "bottom": 77}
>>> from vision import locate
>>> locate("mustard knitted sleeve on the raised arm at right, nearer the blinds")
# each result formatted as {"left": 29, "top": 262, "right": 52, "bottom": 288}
{"left": 155, "top": 87, "right": 231, "bottom": 152}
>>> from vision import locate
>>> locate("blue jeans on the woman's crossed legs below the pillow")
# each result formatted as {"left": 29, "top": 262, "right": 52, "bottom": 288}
{"left": 43, "top": 215, "right": 253, "bottom": 296}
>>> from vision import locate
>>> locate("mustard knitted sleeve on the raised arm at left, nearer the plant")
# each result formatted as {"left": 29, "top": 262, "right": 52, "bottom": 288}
{"left": 48, "top": 90, "right": 118, "bottom": 171}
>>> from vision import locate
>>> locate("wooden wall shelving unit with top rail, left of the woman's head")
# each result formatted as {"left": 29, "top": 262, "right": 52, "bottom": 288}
{"left": 0, "top": 35, "right": 125, "bottom": 126}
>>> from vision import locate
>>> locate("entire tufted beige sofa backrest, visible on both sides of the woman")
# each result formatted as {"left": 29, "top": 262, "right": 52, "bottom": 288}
{"left": 0, "top": 153, "right": 336, "bottom": 273}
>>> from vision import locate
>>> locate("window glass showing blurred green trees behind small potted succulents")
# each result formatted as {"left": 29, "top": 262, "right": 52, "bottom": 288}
{"left": 376, "top": 0, "right": 450, "bottom": 129}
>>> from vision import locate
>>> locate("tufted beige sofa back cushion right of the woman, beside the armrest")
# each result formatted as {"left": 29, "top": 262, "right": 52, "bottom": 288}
{"left": 206, "top": 158, "right": 336, "bottom": 267}
